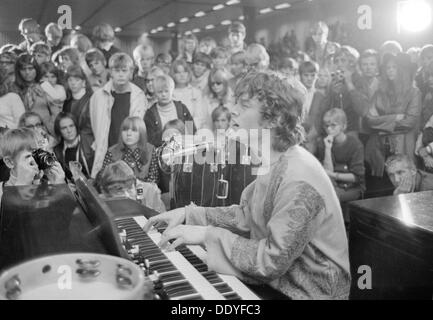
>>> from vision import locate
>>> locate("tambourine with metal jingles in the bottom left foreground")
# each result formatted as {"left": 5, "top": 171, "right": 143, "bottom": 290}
{"left": 0, "top": 253, "right": 153, "bottom": 300}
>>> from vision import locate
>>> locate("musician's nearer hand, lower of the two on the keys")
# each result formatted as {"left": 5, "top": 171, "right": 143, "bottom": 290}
{"left": 159, "top": 225, "right": 208, "bottom": 251}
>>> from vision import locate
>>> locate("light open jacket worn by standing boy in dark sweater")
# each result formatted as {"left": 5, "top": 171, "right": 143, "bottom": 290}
{"left": 89, "top": 80, "right": 148, "bottom": 178}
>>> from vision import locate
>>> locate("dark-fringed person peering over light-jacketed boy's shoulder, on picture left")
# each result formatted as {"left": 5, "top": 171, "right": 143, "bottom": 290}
{"left": 85, "top": 48, "right": 110, "bottom": 91}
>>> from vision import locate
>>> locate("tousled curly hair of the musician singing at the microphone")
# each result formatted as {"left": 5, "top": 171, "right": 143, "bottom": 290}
{"left": 235, "top": 71, "right": 304, "bottom": 152}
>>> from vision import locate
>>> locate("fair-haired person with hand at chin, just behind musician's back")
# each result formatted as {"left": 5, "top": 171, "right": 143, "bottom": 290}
{"left": 316, "top": 108, "right": 365, "bottom": 203}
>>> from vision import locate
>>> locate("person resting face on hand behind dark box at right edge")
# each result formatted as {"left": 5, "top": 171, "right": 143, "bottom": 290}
{"left": 385, "top": 154, "right": 433, "bottom": 195}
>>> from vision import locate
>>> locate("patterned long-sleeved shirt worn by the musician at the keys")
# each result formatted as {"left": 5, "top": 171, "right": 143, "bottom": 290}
{"left": 186, "top": 146, "right": 351, "bottom": 299}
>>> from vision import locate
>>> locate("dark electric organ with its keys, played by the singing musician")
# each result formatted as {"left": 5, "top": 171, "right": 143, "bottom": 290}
{"left": 0, "top": 177, "right": 284, "bottom": 300}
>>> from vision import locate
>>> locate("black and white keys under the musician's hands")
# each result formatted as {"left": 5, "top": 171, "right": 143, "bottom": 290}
{"left": 116, "top": 216, "right": 260, "bottom": 300}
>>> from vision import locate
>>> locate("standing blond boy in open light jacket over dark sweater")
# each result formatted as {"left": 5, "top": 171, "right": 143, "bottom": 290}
{"left": 89, "top": 53, "right": 148, "bottom": 177}
